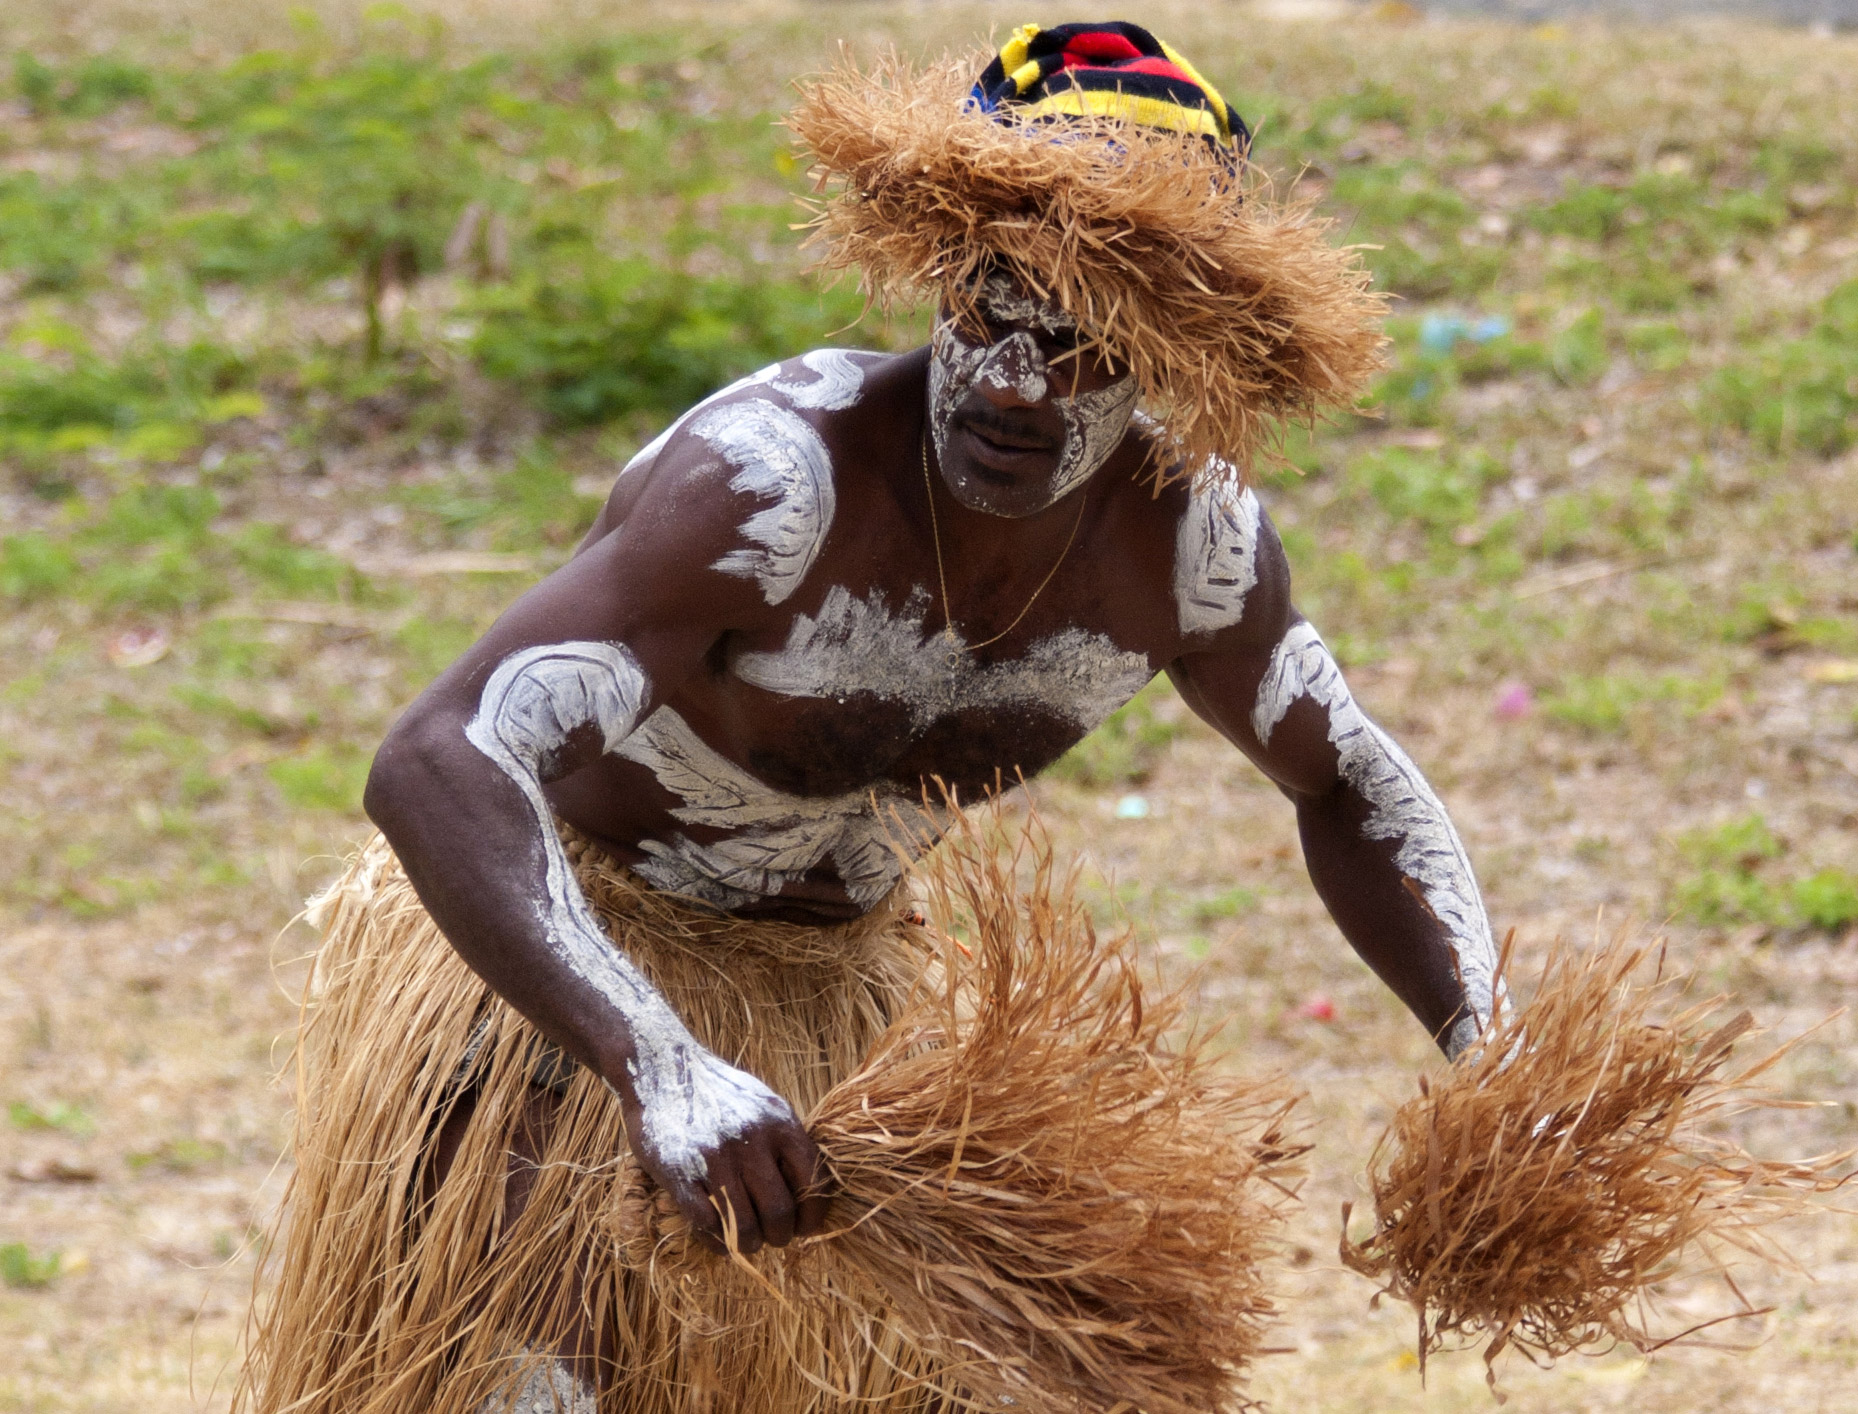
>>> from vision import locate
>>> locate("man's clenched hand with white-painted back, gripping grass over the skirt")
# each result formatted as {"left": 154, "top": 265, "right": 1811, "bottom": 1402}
{"left": 615, "top": 1052, "right": 831, "bottom": 1252}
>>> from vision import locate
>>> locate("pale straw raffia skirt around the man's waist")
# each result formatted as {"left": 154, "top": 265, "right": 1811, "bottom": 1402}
{"left": 236, "top": 836, "right": 942, "bottom": 1414}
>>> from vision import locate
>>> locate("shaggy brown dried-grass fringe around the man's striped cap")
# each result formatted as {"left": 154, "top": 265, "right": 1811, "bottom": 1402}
{"left": 788, "top": 56, "right": 1384, "bottom": 476}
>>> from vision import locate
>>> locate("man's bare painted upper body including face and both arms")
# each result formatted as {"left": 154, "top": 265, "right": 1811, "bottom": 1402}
{"left": 366, "top": 260, "right": 1494, "bottom": 1250}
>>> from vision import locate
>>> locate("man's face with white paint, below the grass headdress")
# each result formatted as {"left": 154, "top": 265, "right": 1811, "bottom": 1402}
{"left": 929, "top": 275, "right": 1137, "bottom": 517}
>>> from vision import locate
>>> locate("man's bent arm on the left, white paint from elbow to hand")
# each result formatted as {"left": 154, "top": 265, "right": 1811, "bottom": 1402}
{"left": 366, "top": 432, "right": 823, "bottom": 1250}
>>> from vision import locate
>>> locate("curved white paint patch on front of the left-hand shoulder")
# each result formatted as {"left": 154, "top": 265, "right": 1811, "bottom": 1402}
{"left": 691, "top": 398, "right": 838, "bottom": 604}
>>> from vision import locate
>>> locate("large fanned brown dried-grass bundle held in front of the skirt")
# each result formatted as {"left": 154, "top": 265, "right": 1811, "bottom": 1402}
{"left": 624, "top": 814, "right": 1306, "bottom": 1414}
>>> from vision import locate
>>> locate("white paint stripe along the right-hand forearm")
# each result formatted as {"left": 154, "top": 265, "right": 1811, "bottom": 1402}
{"left": 1252, "top": 624, "right": 1498, "bottom": 1055}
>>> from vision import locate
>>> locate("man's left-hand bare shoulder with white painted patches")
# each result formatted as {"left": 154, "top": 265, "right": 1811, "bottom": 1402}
{"left": 583, "top": 349, "right": 883, "bottom": 604}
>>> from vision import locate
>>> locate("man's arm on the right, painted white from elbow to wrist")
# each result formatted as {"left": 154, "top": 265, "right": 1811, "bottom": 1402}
{"left": 1169, "top": 490, "right": 1496, "bottom": 1057}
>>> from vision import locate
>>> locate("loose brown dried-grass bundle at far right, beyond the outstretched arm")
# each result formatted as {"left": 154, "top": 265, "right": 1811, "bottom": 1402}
{"left": 1341, "top": 935, "right": 1847, "bottom": 1388}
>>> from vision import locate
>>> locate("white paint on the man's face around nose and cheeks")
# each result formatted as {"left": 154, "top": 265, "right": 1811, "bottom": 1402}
{"left": 929, "top": 281, "right": 1141, "bottom": 515}
